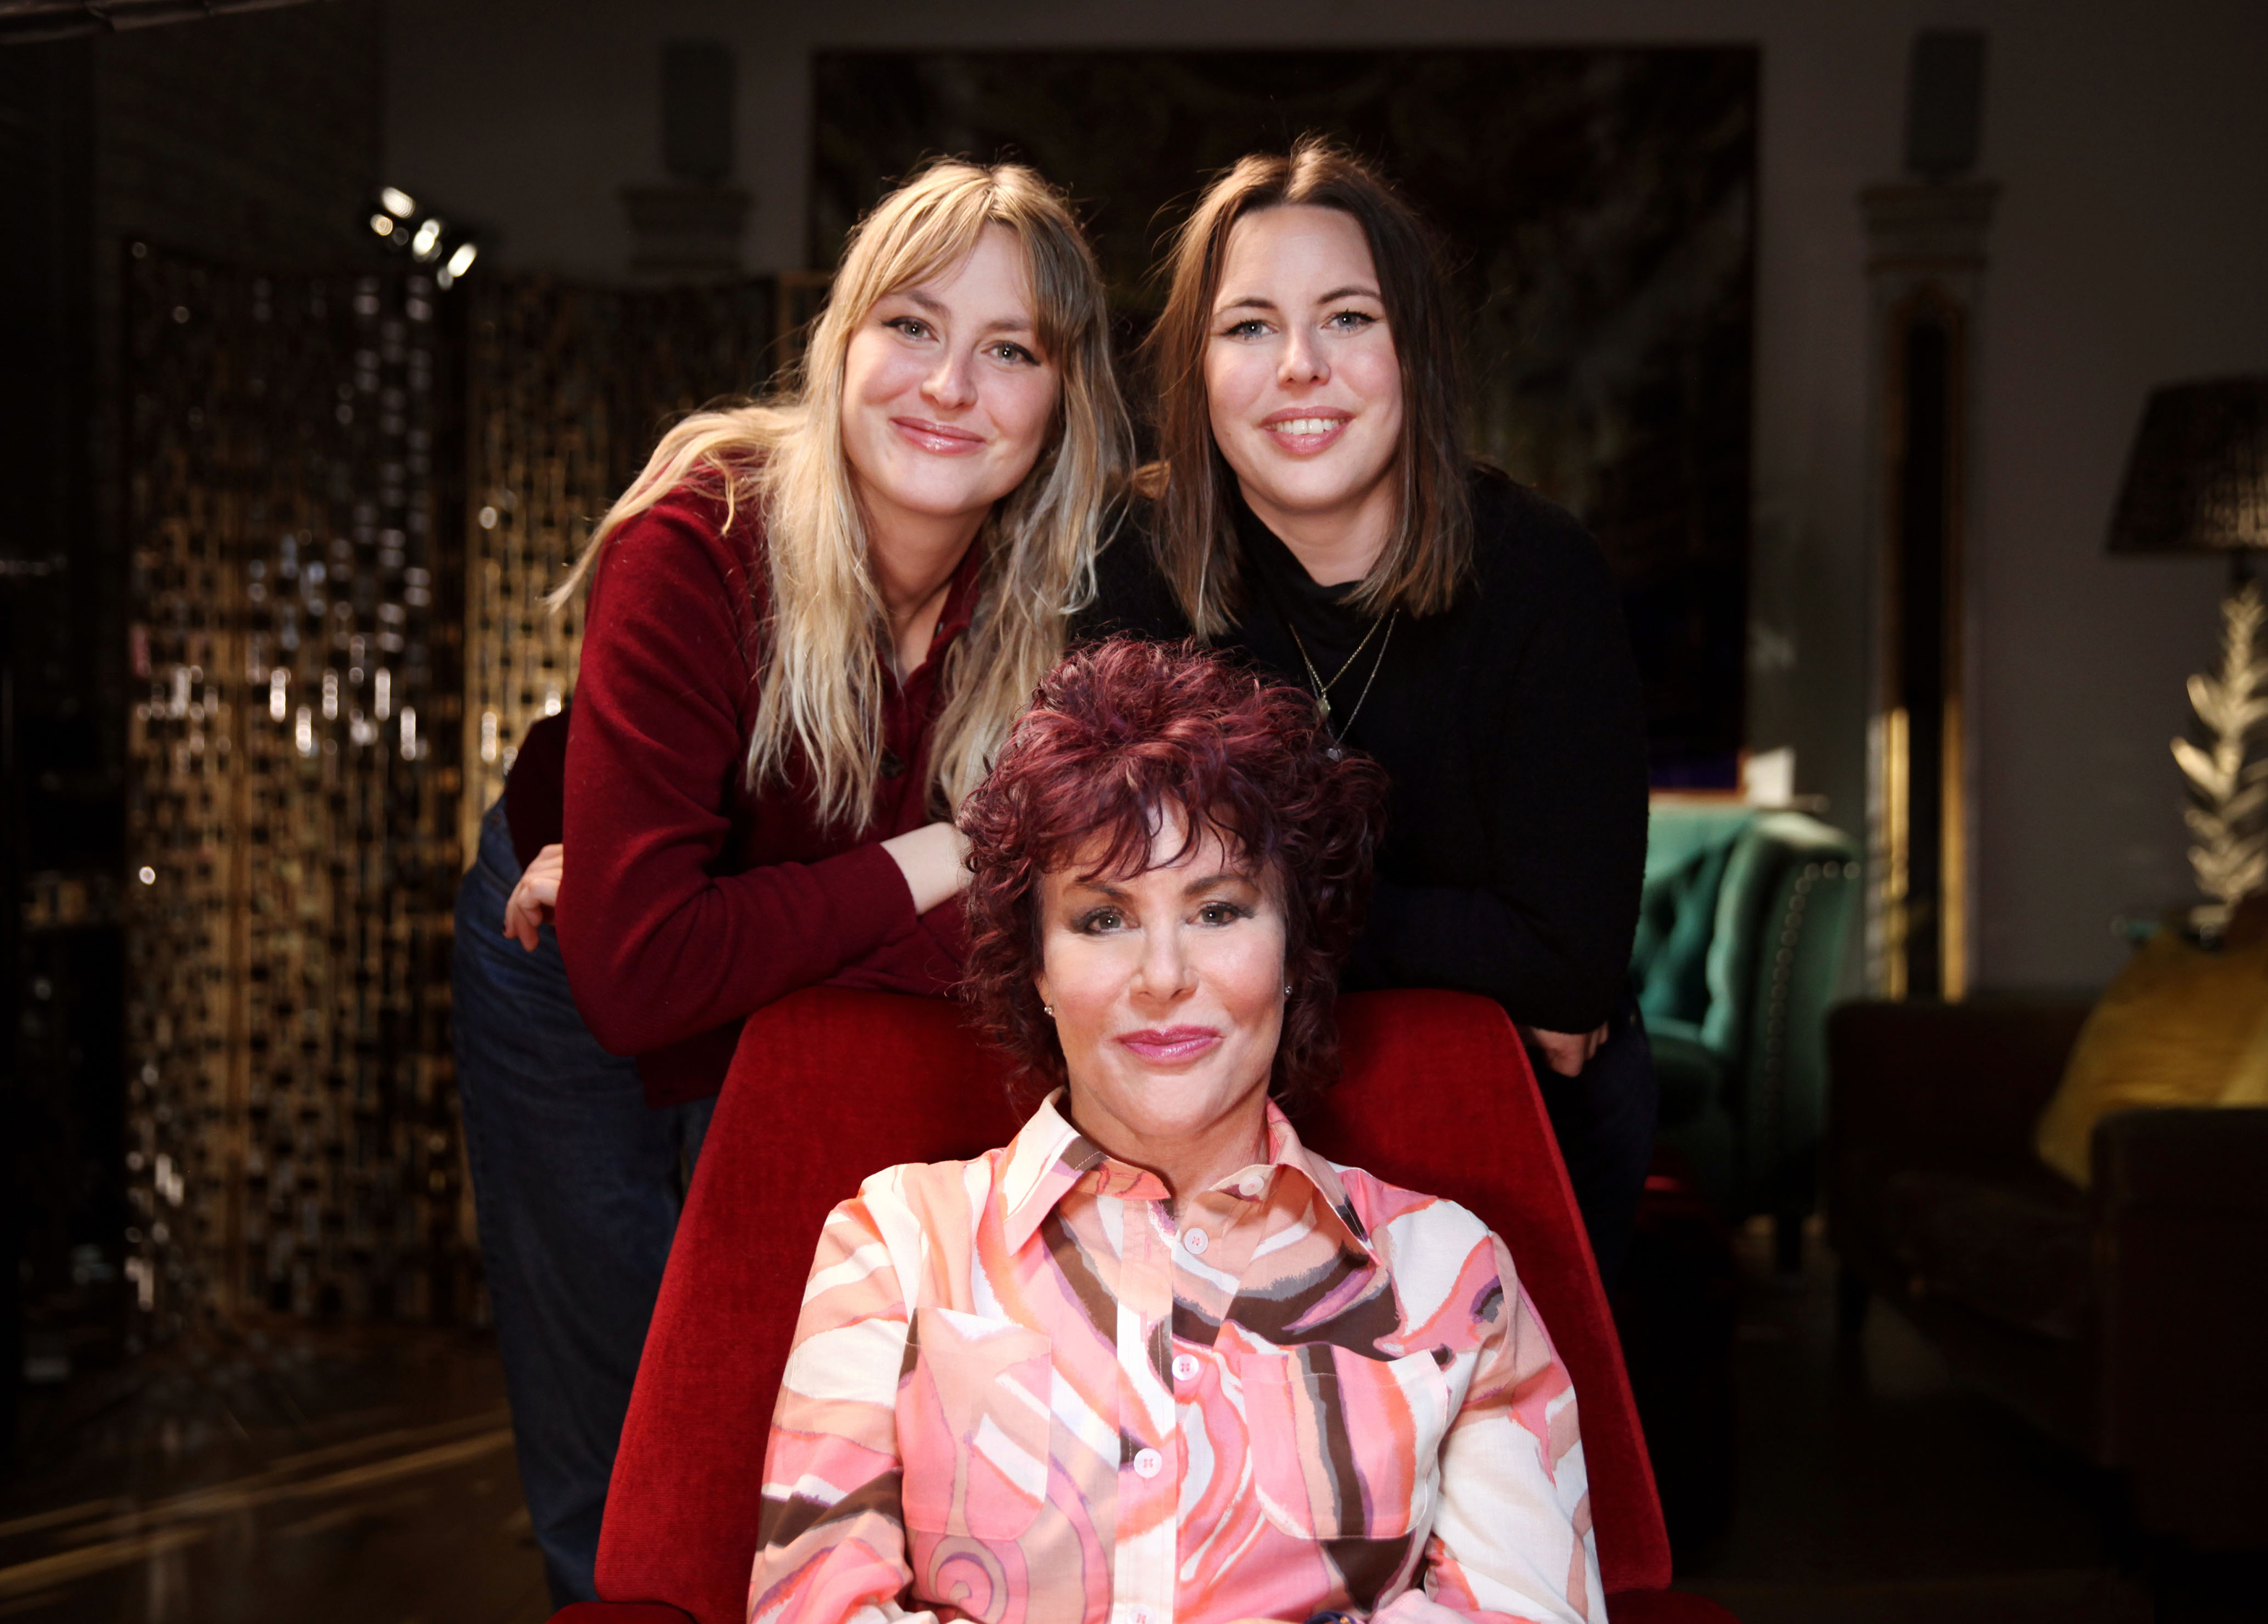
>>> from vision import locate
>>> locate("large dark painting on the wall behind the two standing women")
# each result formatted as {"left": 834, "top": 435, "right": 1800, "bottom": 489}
{"left": 810, "top": 48, "right": 1758, "bottom": 787}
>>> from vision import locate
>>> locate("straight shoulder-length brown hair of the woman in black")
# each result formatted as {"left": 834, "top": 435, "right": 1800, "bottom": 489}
{"left": 1138, "top": 136, "right": 1472, "bottom": 638}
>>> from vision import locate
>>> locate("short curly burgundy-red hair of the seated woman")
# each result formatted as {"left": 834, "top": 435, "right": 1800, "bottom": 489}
{"left": 960, "top": 638, "right": 1386, "bottom": 1100}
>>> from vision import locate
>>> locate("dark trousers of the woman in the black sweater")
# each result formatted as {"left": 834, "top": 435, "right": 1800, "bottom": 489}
{"left": 1528, "top": 998, "right": 1660, "bottom": 1290}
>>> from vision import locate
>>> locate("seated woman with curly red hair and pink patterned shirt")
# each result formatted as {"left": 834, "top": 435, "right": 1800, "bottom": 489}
{"left": 748, "top": 642, "right": 1606, "bottom": 1624}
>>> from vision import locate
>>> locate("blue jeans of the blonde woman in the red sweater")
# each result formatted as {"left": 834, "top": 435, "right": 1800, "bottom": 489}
{"left": 449, "top": 803, "right": 714, "bottom": 1606}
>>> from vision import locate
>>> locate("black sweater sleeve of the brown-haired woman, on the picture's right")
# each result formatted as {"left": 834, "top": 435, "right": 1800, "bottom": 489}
{"left": 1347, "top": 499, "right": 1646, "bottom": 1032}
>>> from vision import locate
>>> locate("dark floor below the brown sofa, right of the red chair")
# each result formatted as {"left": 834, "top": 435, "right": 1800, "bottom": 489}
{"left": 1678, "top": 1225, "right": 2268, "bottom": 1624}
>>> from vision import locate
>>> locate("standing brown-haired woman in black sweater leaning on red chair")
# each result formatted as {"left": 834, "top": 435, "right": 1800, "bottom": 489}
{"left": 1082, "top": 138, "right": 1656, "bottom": 1282}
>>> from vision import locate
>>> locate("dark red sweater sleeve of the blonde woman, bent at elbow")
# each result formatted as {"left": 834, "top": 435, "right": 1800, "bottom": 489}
{"left": 558, "top": 502, "right": 923, "bottom": 1054}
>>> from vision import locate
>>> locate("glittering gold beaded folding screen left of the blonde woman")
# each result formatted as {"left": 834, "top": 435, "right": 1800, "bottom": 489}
{"left": 127, "top": 252, "right": 774, "bottom": 1336}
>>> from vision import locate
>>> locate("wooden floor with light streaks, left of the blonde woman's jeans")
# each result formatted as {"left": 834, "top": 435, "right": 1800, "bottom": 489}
{"left": 0, "top": 1334, "right": 551, "bottom": 1624}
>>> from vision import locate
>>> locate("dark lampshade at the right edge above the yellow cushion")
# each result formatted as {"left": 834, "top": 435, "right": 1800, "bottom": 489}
{"left": 2112, "top": 376, "right": 2268, "bottom": 554}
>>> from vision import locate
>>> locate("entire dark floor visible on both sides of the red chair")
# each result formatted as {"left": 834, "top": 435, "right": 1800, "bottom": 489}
{"left": 0, "top": 1232, "right": 2268, "bottom": 1624}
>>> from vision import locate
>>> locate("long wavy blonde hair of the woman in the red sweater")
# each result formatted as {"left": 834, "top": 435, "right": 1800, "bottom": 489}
{"left": 551, "top": 158, "right": 1132, "bottom": 832}
